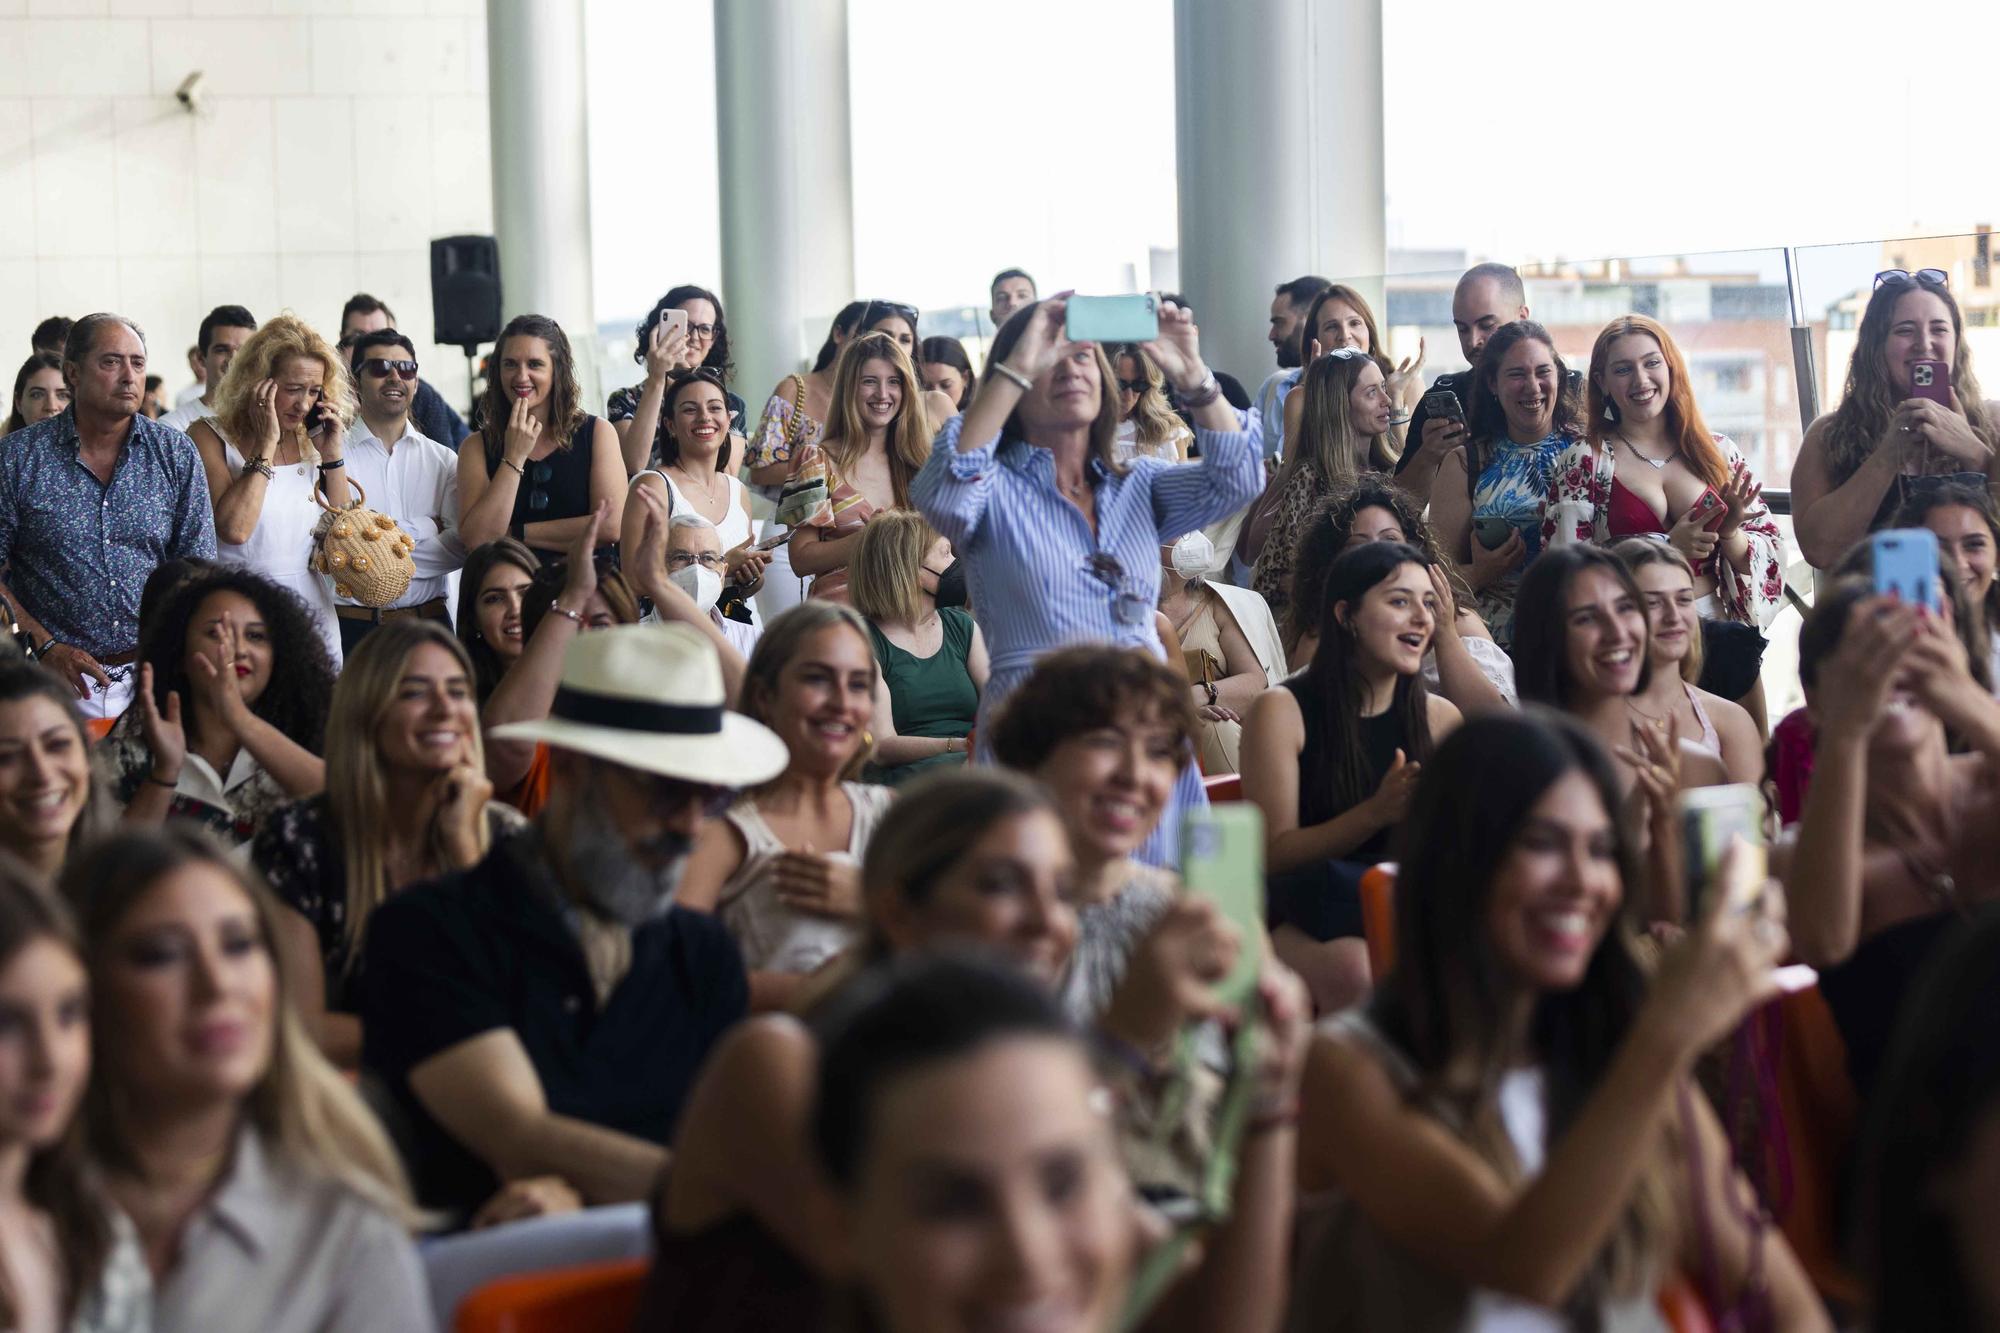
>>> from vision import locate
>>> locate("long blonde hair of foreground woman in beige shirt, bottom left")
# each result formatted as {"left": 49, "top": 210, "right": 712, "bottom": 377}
{"left": 62, "top": 825, "right": 428, "bottom": 1227}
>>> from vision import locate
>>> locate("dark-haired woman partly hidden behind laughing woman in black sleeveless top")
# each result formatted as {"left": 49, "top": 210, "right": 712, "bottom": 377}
{"left": 1282, "top": 476, "right": 1514, "bottom": 715}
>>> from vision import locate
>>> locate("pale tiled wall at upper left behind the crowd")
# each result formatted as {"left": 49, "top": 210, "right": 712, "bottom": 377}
{"left": 0, "top": 0, "right": 492, "bottom": 410}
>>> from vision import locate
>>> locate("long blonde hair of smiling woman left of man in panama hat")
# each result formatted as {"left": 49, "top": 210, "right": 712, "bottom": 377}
{"left": 326, "top": 620, "right": 488, "bottom": 971}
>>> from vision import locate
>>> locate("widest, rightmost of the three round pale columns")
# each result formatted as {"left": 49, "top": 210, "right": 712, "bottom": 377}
{"left": 1174, "top": 0, "right": 1384, "bottom": 390}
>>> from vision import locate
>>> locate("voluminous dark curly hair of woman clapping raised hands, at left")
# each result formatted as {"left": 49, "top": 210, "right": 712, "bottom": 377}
{"left": 140, "top": 566, "right": 334, "bottom": 755}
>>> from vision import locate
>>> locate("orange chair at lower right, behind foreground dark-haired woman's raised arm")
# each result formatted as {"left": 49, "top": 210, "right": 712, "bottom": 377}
{"left": 1764, "top": 987, "right": 1862, "bottom": 1307}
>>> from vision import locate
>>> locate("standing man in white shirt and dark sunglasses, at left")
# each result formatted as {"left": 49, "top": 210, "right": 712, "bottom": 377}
{"left": 334, "top": 328, "right": 466, "bottom": 654}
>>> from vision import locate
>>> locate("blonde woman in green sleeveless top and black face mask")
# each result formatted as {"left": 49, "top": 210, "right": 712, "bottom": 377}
{"left": 848, "top": 508, "right": 988, "bottom": 787}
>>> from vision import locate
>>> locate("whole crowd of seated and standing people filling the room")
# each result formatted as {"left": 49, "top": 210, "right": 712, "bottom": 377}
{"left": 0, "top": 252, "right": 2000, "bottom": 1333}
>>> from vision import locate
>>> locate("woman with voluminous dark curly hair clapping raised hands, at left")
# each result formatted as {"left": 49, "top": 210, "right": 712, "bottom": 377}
{"left": 94, "top": 568, "right": 334, "bottom": 847}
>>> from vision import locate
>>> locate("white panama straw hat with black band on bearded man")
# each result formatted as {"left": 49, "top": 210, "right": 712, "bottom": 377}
{"left": 490, "top": 624, "right": 790, "bottom": 787}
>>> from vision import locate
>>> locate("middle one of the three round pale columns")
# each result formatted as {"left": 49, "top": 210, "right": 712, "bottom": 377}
{"left": 716, "top": 0, "right": 854, "bottom": 412}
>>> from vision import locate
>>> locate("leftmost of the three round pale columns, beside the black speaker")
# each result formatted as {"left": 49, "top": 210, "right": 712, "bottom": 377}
{"left": 486, "top": 0, "right": 604, "bottom": 408}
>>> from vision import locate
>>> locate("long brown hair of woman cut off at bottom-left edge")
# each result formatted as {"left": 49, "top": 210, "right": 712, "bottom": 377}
{"left": 0, "top": 853, "right": 112, "bottom": 1329}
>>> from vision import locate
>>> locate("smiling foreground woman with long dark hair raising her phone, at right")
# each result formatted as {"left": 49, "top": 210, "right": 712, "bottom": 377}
{"left": 1292, "top": 715, "right": 1830, "bottom": 1329}
